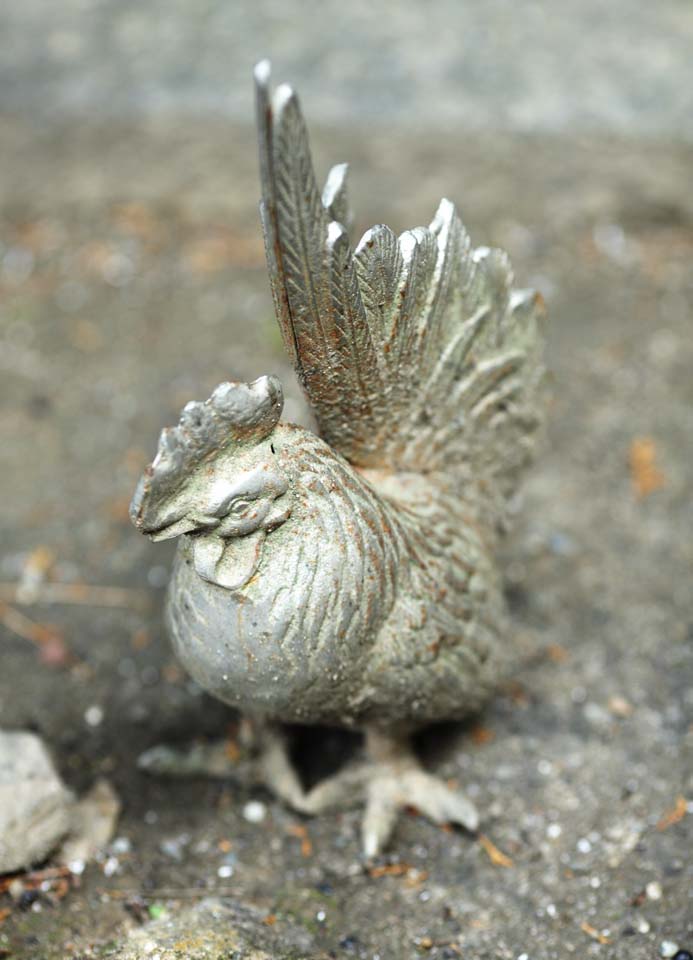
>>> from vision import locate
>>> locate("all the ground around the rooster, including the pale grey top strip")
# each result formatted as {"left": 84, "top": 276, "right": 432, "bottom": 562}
{"left": 0, "top": 0, "right": 693, "bottom": 960}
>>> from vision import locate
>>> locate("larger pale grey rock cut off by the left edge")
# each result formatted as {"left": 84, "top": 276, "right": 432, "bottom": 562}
{"left": 0, "top": 731, "right": 74, "bottom": 873}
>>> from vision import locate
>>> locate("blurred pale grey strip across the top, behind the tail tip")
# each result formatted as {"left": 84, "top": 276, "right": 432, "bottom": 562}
{"left": 0, "top": 0, "right": 693, "bottom": 141}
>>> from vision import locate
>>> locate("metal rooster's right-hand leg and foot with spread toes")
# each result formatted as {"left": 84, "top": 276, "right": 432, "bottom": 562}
{"left": 354, "top": 728, "right": 479, "bottom": 857}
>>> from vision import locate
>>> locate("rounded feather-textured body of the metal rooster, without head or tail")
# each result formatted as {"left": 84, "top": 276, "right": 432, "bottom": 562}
{"left": 168, "top": 424, "right": 503, "bottom": 726}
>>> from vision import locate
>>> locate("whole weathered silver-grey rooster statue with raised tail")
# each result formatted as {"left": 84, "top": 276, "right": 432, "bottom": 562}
{"left": 131, "top": 62, "right": 542, "bottom": 855}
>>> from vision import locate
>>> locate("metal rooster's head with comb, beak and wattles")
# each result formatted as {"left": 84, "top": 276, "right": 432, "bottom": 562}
{"left": 130, "top": 377, "right": 291, "bottom": 589}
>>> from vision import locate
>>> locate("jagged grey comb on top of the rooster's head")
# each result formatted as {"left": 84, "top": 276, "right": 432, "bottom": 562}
{"left": 130, "top": 377, "right": 284, "bottom": 526}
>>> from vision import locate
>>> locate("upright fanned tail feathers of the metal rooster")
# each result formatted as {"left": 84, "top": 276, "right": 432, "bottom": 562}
{"left": 256, "top": 64, "right": 542, "bottom": 502}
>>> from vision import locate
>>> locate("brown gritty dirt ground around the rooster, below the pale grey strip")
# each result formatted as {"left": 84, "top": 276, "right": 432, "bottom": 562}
{"left": 0, "top": 117, "right": 693, "bottom": 960}
